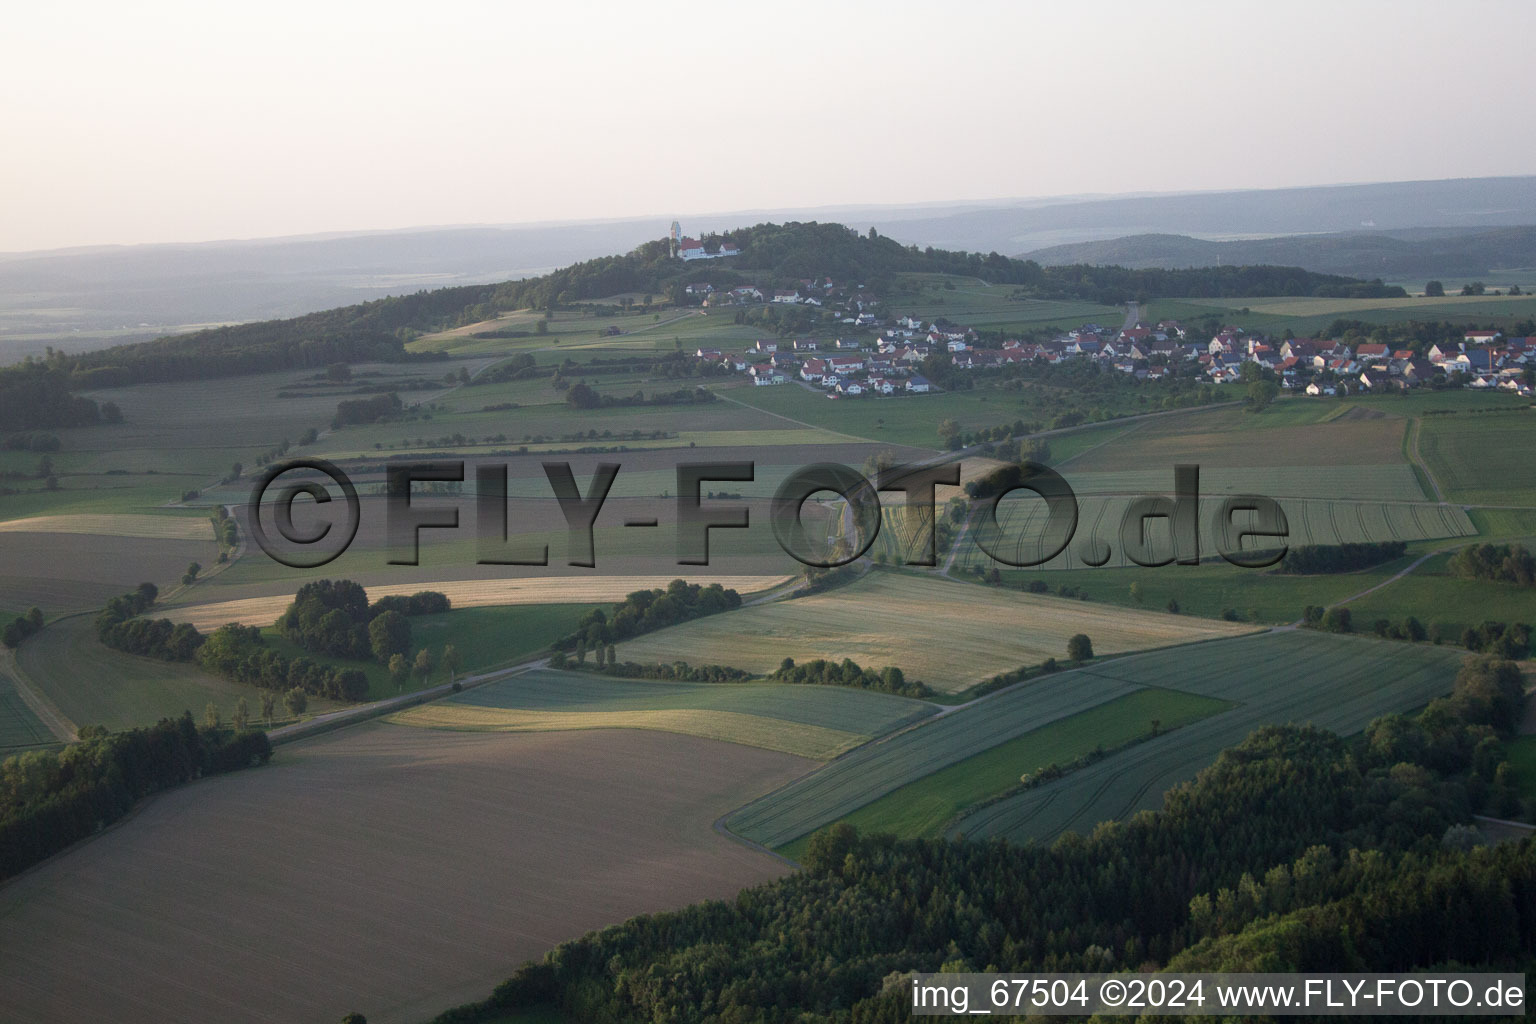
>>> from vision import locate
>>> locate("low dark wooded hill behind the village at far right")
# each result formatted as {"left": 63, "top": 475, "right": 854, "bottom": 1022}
{"left": 1025, "top": 226, "right": 1536, "bottom": 284}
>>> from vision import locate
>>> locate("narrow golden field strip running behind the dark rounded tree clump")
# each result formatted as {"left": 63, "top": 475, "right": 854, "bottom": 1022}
{"left": 164, "top": 576, "right": 790, "bottom": 629}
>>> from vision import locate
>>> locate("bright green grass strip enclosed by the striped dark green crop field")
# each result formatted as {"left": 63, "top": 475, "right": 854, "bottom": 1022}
{"left": 779, "top": 689, "right": 1230, "bottom": 858}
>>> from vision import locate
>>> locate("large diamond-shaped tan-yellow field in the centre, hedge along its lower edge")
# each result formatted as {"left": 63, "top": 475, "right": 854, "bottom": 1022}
{"left": 617, "top": 573, "right": 1253, "bottom": 692}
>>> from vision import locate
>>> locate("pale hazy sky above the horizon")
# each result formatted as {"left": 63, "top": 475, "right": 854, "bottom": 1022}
{"left": 0, "top": 0, "right": 1536, "bottom": 252}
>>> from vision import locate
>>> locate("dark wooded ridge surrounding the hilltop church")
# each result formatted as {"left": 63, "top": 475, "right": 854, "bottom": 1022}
{"left": 9, "top": 223, "right": 1402, "bottom": 399}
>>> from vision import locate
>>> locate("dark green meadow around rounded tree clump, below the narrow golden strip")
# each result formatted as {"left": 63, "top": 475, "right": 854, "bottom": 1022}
{"left": 263, "top": 605, "right": 602, "bottom": 700}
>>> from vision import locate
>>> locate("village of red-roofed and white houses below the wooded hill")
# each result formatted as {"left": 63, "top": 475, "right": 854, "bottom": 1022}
{"left": 685, "top": 278, "right": 1536, "bottom": 399}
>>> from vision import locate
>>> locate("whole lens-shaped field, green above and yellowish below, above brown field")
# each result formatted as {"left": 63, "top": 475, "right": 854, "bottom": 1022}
{"left": 390, "top": 669, "right": 934, "bottom": 760}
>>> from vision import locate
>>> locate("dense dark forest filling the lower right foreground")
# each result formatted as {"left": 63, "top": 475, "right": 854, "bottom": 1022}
{"left": 423, "top": 660, "right": 1536, "bottom": 1024}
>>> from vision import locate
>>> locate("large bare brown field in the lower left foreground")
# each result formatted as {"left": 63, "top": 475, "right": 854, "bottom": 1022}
{"left": 0, "top": 723, "right": 811, "bottom": 1024}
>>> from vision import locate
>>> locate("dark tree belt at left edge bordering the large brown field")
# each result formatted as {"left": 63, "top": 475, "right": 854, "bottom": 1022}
{"left": 0, "top": 711, "right": 272, "bottom": 878}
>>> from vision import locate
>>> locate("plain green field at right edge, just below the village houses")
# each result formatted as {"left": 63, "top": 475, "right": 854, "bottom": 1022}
{"left": 1419, "top": 408, "right": 1536, "bottom": 505}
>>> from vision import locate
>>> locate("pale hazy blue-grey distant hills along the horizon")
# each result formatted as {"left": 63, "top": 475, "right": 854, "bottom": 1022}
{"left": 0, "top": 177, "right": 1536, "bottom": 364}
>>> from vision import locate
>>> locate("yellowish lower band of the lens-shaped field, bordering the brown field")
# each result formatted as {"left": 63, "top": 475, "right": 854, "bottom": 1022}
{"left": 387, "top": 703, "right": 868, "bottom": 761}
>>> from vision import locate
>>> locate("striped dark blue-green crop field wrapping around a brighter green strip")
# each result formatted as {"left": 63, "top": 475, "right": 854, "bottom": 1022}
{"left": 727, "top": 631, "right": 1461, "bottom": 847}
